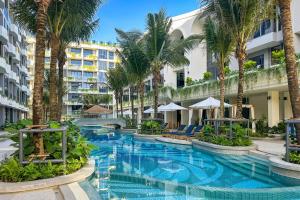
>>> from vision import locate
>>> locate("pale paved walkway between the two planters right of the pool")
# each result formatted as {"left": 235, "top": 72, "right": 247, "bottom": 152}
{"left": 253, "top": 140, "right": 285, "bottom": 157}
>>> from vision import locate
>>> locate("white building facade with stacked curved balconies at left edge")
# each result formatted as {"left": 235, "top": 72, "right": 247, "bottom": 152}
{"left": 0, "top": 0, "right": 30, "bottom": 126}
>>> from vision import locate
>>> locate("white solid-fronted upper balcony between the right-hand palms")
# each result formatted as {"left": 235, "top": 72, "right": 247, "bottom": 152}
{"left": 247, "top": 31, "right": 283, "bottom": 53}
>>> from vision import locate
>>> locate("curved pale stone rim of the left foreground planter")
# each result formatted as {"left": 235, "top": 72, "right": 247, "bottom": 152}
{"left": 0, "top": 160, "right": 95, "bottom": 194}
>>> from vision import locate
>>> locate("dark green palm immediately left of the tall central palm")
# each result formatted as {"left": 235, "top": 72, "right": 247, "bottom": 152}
{"left": 116, "top": 29, "right": 150, "bottom": 120}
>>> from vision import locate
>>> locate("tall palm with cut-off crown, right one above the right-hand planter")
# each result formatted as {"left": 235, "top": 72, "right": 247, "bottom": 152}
{"left": 206, "top": 0, "right": 274, "bottom": 118}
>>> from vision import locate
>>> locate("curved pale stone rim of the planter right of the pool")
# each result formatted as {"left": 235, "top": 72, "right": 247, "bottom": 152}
{"left": 192, "top": 140, "right": 256, "bottom": 155}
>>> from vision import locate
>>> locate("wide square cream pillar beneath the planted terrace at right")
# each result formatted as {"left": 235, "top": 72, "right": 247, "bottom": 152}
{"left": 267, "top": 91, "right": 280, "bottom": 127}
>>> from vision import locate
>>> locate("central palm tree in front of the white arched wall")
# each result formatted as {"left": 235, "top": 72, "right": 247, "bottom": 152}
{"left": 143, "top": 10, "right": 200, "bottom": 118}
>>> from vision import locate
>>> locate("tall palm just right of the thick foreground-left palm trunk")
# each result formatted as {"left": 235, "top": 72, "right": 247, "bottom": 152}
{"left": 48, "top": 0, "right": 101, "bottom": 120}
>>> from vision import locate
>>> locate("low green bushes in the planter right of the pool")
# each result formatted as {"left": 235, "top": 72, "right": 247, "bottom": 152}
{"left": 197, "top": 124, "right": 252, "bottom": 146}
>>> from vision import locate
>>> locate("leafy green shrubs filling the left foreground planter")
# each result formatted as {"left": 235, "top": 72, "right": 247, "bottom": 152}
{"left": 0, "top": 119, "right": 94, "bottom": 182}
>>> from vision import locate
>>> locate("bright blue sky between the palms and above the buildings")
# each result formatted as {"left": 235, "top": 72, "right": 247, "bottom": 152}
{"left": 91, "top": 0, "right": 200, "bottom": 42}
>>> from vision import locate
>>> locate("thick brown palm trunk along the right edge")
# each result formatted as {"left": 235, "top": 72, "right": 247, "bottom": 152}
{"left": 279, "top": 0, "right": 300, "bottom": 144}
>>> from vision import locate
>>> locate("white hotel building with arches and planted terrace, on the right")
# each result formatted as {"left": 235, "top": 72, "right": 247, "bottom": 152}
{"left": 120, "top": 0, "right": 300, "bottom": 126}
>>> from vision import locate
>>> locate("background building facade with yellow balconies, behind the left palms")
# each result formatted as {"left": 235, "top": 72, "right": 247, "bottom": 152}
{"left": 28, "top": 38, "right": 118, "bottom": 119}
